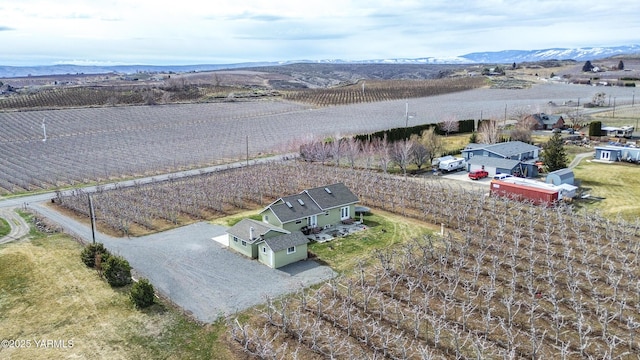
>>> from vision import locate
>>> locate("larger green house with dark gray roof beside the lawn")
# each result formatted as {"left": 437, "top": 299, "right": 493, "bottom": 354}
{"left": 260, "top": 183, "right": 360, "bottom": 232}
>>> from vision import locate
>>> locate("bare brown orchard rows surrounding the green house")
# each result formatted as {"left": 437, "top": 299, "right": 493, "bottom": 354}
{"left": 55, "top": 162, "right": 640, "bottom": 359}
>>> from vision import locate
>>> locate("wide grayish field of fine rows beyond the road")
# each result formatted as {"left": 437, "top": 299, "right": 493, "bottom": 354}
{"left": 0, "top": 84, "right": 632, "bottom": 194}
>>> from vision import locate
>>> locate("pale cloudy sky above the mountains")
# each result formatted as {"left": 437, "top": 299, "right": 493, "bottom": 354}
{"left": 0, "top": 0, "right": 640, "bottom": 66}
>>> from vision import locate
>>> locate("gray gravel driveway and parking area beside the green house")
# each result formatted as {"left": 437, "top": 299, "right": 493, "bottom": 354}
{"left": 31, "top": 204, "right": 336, "bottom": 323}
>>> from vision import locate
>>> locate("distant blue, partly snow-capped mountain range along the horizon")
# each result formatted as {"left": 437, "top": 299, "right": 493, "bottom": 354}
{"left": 0, "top": 45, "right": 640, "bottom": 78}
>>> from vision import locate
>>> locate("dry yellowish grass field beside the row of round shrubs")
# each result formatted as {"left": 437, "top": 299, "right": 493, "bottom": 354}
{"left": 0, "top": 224, "right": 235, "bottom": 359}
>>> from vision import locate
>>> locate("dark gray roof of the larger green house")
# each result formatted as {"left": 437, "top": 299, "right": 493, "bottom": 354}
{"left": 267, "top": 183, "right": 360, "bottom": 224}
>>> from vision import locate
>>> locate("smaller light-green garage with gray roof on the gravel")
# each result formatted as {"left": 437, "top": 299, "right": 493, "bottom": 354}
{"left": 227, "top": 219, "right": 309, "bottom": 269}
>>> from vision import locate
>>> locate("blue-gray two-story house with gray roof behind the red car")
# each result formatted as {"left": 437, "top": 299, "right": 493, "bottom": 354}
{"left": 462, "top": 141, "right": 540, "bottom": 177}
